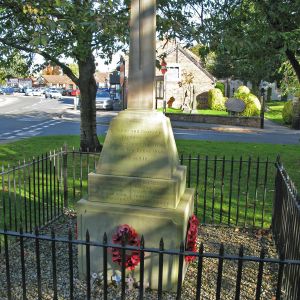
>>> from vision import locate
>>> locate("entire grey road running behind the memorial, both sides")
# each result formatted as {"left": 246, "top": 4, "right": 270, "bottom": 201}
{"left": 0, "top": 95, "right": 300, "bottom": 144}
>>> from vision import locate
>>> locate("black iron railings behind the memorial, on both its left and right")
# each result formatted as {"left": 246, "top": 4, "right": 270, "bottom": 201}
{"left": 0, "top": 149, "right": 275, "bottom": 232}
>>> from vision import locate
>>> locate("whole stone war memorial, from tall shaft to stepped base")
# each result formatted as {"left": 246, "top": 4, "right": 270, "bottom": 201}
{"left": 78, "top": 0, "right": 194, "bottom": 290}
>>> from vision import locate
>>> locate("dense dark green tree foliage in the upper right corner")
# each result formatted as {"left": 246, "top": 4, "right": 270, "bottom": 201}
{"left": 180, "top": 0, "right": 300, "bottom": 91}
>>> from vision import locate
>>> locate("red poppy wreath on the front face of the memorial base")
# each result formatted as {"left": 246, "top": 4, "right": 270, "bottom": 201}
{"left": 112, "top": 224, "right": 141, "bottom": 270}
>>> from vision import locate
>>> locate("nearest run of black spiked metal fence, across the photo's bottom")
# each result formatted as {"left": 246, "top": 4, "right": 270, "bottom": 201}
{"left": 0, "top": 229, "right": 300, "bottom": 299}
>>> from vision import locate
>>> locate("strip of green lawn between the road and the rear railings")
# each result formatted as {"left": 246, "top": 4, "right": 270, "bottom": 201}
{"left": 0, "top": 135, "right": 300, "bottom": 186}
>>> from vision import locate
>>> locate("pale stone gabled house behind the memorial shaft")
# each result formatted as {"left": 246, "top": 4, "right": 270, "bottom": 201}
{"left": 125, "top": 41, "right": 216, "bottom": 108}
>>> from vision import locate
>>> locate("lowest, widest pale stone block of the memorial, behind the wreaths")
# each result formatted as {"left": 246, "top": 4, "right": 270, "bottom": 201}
{"left": 78, "top": 189, "right": 194, "bottom": 290}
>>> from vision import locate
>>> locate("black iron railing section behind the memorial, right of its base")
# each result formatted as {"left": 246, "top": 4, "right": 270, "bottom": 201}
{"left": 180, "top": 155, "right": 274, "bottom": 228}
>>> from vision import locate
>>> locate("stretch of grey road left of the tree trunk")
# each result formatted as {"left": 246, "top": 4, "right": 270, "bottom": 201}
{"left": 0, "top": 95, "right": 79, "bottom": 143}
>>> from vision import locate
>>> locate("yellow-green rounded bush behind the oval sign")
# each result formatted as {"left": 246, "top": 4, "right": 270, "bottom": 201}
{"left": 234, "top": 85, "right": 261, "bottom": 117}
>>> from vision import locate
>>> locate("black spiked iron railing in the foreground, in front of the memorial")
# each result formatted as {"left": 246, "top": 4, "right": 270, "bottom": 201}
{"left": 0, "top": 229, "right": 300, "bottom": 299}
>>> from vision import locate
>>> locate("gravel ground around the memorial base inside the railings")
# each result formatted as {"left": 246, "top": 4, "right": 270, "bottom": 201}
{"left": 0, "top": 213, "right": 277, "bottom": 300}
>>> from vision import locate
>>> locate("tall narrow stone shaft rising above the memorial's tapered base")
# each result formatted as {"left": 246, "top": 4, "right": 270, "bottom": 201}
{"left": 127, "top": 0, "right": 156, "bottom": 110}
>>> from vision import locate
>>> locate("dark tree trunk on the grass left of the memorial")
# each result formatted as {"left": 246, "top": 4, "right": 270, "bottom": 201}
{"left": 78, "top": 54, "right": 102, "bottom": 151}
